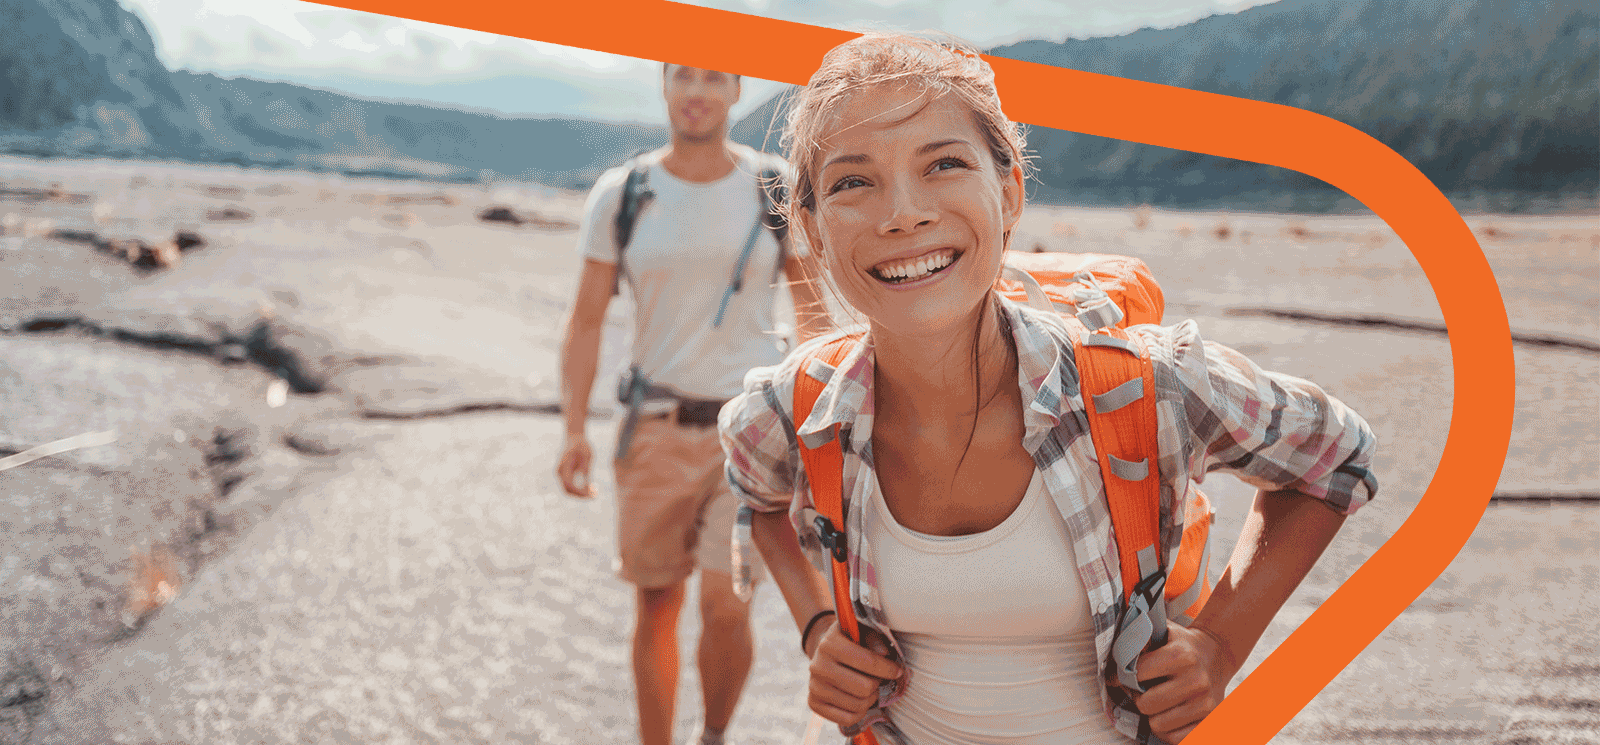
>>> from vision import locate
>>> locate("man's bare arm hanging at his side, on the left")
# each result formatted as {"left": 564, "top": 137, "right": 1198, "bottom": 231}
{"left": 557, "top": 259, "right": 616, "bottom": 497}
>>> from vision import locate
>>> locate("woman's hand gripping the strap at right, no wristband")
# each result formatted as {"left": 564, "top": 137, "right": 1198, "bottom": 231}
{"left": 1133, "top": 622, "right": 1238, "bottom": 743}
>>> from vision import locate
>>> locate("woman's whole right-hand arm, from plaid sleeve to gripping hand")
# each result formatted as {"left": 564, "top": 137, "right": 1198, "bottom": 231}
{"left": 1138, "top": 321, "right": 1378, "bottom": 742}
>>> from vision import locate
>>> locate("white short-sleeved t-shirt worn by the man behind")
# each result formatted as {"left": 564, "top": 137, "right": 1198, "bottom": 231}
{"left": 578, "top": 145, "right": 784, "bottom": 400}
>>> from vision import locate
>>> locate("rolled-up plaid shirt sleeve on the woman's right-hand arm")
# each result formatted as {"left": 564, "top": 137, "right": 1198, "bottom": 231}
{"left": 1157, "top": 321, "right": 1378, "bottom": 515}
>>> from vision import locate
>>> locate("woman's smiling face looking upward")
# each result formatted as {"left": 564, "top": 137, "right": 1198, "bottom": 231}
{"left": 802, "top": 85, "right": 1022, "bottom": 336}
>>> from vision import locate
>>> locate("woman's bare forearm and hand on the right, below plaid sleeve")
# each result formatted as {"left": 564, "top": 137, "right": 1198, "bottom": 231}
{"left": 1136, "top": 491, "right": 1344, "bottom": 742}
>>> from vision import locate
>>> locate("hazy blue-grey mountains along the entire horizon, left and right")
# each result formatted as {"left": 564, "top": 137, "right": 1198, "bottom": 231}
{"left": 0, "top": 0, "right": 1600, "bottom": 211}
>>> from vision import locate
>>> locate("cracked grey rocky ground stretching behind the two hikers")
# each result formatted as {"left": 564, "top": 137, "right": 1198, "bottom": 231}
{"left": 0, "top": 152, "right": 1600, "bottom": 745}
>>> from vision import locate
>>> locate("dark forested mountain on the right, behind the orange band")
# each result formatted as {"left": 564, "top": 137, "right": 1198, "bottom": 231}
{"left": 733, "top": 0, "right": 1600, "bottom": 211}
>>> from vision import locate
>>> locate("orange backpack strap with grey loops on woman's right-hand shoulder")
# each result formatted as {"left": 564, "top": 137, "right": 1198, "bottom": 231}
{"left": 1066, "top": 318, "right": 1166, "bottom": 691}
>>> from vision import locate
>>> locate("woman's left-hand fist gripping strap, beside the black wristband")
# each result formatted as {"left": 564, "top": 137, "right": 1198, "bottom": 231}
{"left": 806, "top": 619, "right": 901, "bottom": 727}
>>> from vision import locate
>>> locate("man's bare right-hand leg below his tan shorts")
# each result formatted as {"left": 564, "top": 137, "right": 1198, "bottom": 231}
{"left": 698, "top": 569, "right": 755, "bottom": 732}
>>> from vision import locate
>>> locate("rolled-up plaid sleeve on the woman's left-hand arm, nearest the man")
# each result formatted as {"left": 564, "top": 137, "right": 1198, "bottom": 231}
{"left": 717, "top": 365, "right": 800, "bottom": 512}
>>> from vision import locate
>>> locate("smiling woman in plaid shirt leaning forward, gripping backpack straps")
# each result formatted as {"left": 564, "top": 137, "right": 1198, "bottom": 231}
{"left": 718, "top": 34, "right": 1376, "bottom": 745}
